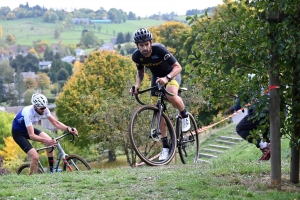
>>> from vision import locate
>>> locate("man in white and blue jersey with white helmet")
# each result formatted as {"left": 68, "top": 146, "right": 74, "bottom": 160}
{"left": 12, "top": 93, "right": 78, "bottom": 174}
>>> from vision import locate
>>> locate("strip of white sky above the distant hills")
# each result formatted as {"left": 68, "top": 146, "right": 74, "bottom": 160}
{"left": 0, "top": 0, "right": 223, "bottom": 17}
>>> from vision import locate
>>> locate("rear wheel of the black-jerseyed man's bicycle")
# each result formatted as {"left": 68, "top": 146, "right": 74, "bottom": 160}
{"left": 176, "top": 113, "right": 199, "bottom": 164}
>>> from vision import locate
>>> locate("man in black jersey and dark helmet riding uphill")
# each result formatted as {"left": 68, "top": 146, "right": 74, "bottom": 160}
{"left": 130, "top": 28, "right": 191, "bottom": 160}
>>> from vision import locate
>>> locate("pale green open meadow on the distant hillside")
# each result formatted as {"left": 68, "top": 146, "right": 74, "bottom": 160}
{"left": 0, "top": 17, "right": 164, "bottom": 45}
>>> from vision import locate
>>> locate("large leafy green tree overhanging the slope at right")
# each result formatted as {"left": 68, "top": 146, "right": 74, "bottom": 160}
{"left": 186, "top": 0, "right": 300, "bottom": 187}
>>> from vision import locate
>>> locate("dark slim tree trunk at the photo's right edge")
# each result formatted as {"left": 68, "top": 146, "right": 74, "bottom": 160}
{"left": 290, "top": 60, "right": 300, "bottom": 183}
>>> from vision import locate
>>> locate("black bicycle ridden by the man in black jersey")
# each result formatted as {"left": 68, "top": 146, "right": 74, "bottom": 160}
{"left": 129, "top": 84, "right": 199, "bottom": 166}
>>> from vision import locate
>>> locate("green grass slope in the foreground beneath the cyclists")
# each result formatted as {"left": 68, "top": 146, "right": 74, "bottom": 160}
{"left": 0, "top": 125, "right": 300, "bottom": 200}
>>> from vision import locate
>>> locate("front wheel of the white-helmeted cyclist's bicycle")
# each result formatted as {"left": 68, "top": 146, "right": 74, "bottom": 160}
{"left": 63, "top": 155, "right": 92, "bottom": 171}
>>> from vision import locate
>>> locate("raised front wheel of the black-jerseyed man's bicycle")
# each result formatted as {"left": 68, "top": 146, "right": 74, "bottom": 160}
{"left": 129, "top": 105, "right": 177, "bottom": 166}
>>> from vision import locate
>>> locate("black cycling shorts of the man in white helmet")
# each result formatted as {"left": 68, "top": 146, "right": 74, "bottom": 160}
{"left": 12, "top": 128, "right": 42, "bottom": 154}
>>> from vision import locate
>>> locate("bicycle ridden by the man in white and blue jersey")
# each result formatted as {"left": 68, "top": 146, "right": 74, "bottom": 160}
{"left": 17, "top": 132, "right": 91, "bottom": 175}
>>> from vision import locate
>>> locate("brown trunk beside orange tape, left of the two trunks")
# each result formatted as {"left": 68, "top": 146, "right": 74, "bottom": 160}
{"left": 269, "top": 36, "right": 281, "bottom": 190}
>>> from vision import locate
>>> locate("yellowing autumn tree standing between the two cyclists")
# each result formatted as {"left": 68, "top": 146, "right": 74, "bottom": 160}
{"left": 55, "top": 51, "right": 136, "bottom": 161}
